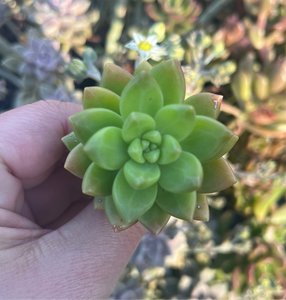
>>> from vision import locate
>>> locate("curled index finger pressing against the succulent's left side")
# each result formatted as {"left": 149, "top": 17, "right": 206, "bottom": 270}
{"left": 0, "top": 100, "right": 82, "bottom": 211}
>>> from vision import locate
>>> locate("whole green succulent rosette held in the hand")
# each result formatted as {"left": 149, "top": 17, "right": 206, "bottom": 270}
{"left": 62, "top": 60, "right": 238, "bottom": 234}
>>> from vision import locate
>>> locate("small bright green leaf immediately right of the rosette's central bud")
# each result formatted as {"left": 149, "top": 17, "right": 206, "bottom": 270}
{"left": 158, "top": 134, "right": 182, "bottom": 165}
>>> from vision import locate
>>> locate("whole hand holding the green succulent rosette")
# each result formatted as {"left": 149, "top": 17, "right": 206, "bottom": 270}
{"left": 0, "top": 100, "right": 146, "bottom": 300}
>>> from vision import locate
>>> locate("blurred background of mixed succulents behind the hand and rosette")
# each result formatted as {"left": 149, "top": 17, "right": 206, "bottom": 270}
{"left": 0, "top": 0, "right": 286, "bottom": 300}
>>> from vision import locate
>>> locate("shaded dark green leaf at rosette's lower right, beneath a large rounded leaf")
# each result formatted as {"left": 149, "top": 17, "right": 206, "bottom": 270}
{"left": 156, "top": 186, "right": 197, "bottom": 222}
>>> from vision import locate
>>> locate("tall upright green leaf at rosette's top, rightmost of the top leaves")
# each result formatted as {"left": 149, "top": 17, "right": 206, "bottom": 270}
{"left": 149, "top": 59, "right": 186, "bottom": 105}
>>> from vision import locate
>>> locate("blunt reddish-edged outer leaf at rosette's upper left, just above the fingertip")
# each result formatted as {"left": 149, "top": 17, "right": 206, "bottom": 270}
{"left": 82, "top": 86, "right": 120, "bottom": 114}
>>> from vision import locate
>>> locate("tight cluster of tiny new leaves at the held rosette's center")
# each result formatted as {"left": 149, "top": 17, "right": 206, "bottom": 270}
{"left": 128, "top": 130, "right": 162, "bottom": 164}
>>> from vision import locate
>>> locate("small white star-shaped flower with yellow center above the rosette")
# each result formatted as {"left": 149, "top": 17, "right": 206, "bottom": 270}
{"left": 125, "top": 33, "right": 165, "bottom": 61}
